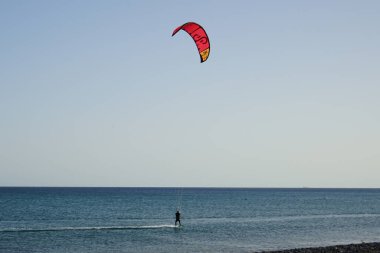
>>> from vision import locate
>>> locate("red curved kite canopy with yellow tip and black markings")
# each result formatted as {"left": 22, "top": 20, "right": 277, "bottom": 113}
{"left": 172, "top": 22, "right": 210, "bottom": 62}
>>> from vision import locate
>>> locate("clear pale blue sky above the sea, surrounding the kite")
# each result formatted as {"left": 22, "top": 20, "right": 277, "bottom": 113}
{"left": 0, "top": 0, "right": 380, "bottom": 187}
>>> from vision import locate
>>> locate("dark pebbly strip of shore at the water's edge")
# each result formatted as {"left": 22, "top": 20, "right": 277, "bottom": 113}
{"left": 259, "top": 242, "right": 380, "bottom": 253}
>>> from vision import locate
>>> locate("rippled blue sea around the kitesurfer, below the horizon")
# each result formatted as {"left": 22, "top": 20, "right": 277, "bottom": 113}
{"left": 0, "top": 187, "right": 380, "bottom": 253}
